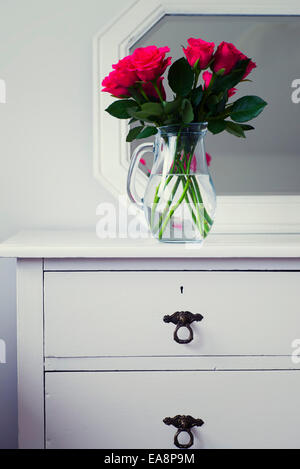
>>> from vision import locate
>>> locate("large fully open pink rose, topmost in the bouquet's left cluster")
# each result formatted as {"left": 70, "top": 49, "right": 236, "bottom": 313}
{"left": 130, "top": 46, "right": 171, "bottom": 81}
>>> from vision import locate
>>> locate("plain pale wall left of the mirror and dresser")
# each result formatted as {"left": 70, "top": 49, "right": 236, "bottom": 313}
{"left": 0, "top": 0, "right": 133, "bottom": 448}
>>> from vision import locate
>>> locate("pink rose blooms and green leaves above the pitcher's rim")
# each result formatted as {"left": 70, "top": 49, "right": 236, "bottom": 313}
{"left": 102, "top": 38, "right": 267, "bottom": 142}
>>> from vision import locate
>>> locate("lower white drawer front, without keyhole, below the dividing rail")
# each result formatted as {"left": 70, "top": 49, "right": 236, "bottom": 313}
{"left": 46, "top": 371, "right": 300, "bottom": 449}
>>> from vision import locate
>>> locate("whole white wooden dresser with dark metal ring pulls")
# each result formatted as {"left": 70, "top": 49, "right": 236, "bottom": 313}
{"left": 0, "top": 231, "right": 300, "bottom": 449}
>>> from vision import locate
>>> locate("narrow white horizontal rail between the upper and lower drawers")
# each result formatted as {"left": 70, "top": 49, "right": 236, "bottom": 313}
{"left": 45, "top": 355, "right": 300, "bottom": 372}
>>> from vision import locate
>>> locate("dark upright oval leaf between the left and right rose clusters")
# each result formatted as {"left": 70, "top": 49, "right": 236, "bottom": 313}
{"left": 168, "top": 57, "right": 195, "bottom": 96}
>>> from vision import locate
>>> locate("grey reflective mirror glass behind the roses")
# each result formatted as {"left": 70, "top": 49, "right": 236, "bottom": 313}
{"left": 131, "top": 15, "right": 300, "bottom": 195}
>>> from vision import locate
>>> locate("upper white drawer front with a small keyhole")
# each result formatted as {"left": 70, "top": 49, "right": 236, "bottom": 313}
{"left": 44, "top": 272, "right": 300, "bottom": 357}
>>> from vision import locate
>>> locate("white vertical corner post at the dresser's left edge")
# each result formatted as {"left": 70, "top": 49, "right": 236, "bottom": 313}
{"left": 17, "top": 259, "right": 44, "bottom": 449}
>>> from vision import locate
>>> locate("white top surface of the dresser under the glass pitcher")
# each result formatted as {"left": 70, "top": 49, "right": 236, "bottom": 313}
{"left": 0, "top": 230, "right": 300, "bottom": 259}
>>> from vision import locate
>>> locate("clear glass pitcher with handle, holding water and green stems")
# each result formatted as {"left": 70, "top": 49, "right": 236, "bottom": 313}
{"left": 127, "top": 123, "right": 216, "bottom": 243}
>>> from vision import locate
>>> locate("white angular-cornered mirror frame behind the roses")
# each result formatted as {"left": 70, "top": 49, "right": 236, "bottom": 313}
{"left": 93, "top": 0, "right": 300, "bottom": 233}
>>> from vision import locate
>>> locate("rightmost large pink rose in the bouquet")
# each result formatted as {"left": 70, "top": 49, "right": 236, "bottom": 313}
{"left": 211, "top": 41, "right": 256, "bottom": 78}
